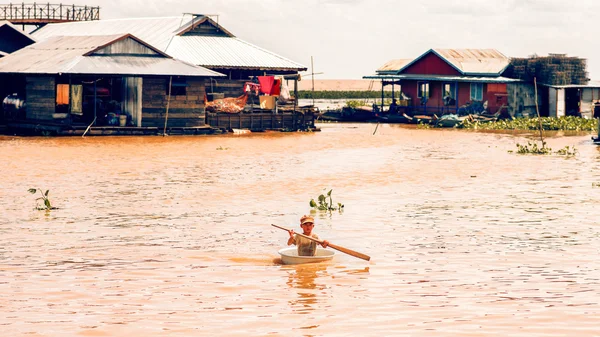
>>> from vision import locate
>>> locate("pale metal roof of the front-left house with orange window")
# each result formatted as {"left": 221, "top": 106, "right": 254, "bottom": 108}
{"left": 0, "top": 35, "right": 223, "bottom": 76}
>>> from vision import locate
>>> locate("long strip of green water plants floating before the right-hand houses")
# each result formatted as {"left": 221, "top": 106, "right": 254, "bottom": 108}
{"left": 461, "top": 116, "right": 598, "bottom": 131}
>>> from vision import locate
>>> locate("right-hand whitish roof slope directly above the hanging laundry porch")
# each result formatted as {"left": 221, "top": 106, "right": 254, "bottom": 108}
{"left": 166, "top": 36, "right": 306, "bottom": 70}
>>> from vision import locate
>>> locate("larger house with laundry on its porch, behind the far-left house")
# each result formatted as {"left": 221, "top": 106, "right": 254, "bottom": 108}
{"left": 27, "top": 14, "right": 315, "bottom": 130}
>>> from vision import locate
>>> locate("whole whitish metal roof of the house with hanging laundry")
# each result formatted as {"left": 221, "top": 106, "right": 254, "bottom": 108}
{"left": 33, "top": 16, "right": 307, "bottom": 71}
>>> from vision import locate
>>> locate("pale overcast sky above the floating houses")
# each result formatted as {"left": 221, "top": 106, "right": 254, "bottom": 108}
{"left": 75, "top": 0, "right": 600, "bottom": 80}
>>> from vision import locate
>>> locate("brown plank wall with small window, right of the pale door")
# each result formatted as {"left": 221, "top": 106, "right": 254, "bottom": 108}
{"left": 142, "top": 77, "right": 206, "bottom": 127}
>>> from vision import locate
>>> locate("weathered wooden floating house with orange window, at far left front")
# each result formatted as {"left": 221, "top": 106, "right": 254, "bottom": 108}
{"left": 0, "top": 34, "right": 223, "bottom": 134}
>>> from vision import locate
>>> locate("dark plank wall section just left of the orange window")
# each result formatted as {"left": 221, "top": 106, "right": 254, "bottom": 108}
{"left": 25, "top": 76, "right": 56, "bottom": 120}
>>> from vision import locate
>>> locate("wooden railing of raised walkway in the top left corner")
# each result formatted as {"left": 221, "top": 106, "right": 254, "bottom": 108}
{"left": 0, "top": 2, "right": 100, "bottom": 24}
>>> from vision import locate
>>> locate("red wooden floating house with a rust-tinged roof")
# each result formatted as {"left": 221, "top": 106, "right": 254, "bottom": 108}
{"left": 364, "top": 49, "right": 520, "bottom": 116}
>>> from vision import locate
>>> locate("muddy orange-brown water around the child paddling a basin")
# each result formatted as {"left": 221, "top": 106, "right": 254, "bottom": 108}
{"left": 0, "top": 124, "right": 600, "bottom": 337}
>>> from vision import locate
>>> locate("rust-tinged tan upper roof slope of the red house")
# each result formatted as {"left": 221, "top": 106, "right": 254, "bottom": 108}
{"left": 433, "top": 49, "right": 510, "bottom": 74}
